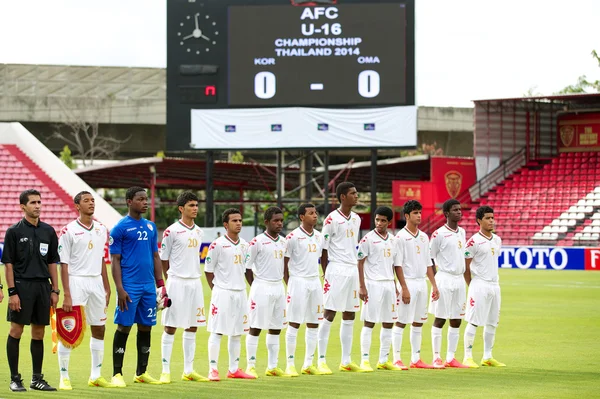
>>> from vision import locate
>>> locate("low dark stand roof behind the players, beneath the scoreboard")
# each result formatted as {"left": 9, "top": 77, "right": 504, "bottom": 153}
{"left": 75, "top": 155, "right": 430, "bottom": 192}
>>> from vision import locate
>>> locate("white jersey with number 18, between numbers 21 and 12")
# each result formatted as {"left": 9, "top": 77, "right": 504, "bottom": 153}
{"left": 246, "top": 232, "right": 285, "bottom": 281}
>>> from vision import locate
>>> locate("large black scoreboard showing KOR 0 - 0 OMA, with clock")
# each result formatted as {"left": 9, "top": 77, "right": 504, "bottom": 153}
{"left": 167, "top": 0, "right": 415, "bottom": 151}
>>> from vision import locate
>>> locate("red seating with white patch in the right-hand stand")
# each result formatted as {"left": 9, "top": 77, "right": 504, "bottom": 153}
{"left": 422, "top": 152, "right": 600, "bottom": 246}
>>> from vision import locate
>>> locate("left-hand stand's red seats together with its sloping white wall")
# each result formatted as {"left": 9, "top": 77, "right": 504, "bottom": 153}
{"left": 0, "top": 123, "right": 121, "bottom": 238}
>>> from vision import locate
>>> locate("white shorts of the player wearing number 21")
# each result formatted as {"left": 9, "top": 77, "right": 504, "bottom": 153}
{"left": 207, "top": 286, "right": 250, "bottom": 336}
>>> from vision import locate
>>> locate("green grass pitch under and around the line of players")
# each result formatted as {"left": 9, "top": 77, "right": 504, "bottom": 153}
{"left": 0, "top": 270, "right": 600, "bottom": 399}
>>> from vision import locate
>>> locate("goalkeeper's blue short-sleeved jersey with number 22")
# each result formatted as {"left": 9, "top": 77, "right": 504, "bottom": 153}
{"left": 109, "top": 215, "right": 158, "bottom": 287}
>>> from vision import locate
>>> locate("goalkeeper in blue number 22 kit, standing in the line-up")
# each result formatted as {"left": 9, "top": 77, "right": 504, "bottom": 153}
{"left": 109, "top": 187, "right": 166, "bottom": 387}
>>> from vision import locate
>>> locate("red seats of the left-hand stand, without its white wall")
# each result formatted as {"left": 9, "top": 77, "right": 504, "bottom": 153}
{"left": 0, "top": 144, "right": 77, "bottom": 242}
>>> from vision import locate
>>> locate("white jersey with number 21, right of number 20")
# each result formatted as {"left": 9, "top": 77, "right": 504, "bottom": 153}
{"left": 204, "top": 234, "right": 248, "bottom": 291}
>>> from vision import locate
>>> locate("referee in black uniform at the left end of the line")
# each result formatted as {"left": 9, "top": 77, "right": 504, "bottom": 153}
{"left": 2, "top": 190, "right": 60, "bottom": 392}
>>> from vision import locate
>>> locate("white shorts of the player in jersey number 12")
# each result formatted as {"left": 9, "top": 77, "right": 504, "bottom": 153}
{"left": 287, "top": 277, "right": 323, "bottom": 324}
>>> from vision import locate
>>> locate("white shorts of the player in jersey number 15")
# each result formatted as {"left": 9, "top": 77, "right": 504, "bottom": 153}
{"left": 360, "top": 279, "right": 398, "bottom": 323}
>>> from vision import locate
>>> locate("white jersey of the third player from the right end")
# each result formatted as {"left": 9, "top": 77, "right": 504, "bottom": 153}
{"left": 394, "top": 227, "right": 432, "bottom": 278}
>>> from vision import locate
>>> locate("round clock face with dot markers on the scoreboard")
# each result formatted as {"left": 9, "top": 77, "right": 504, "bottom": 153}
{"left": 177, "top": 12, "right": 220, "bottom": 55}
